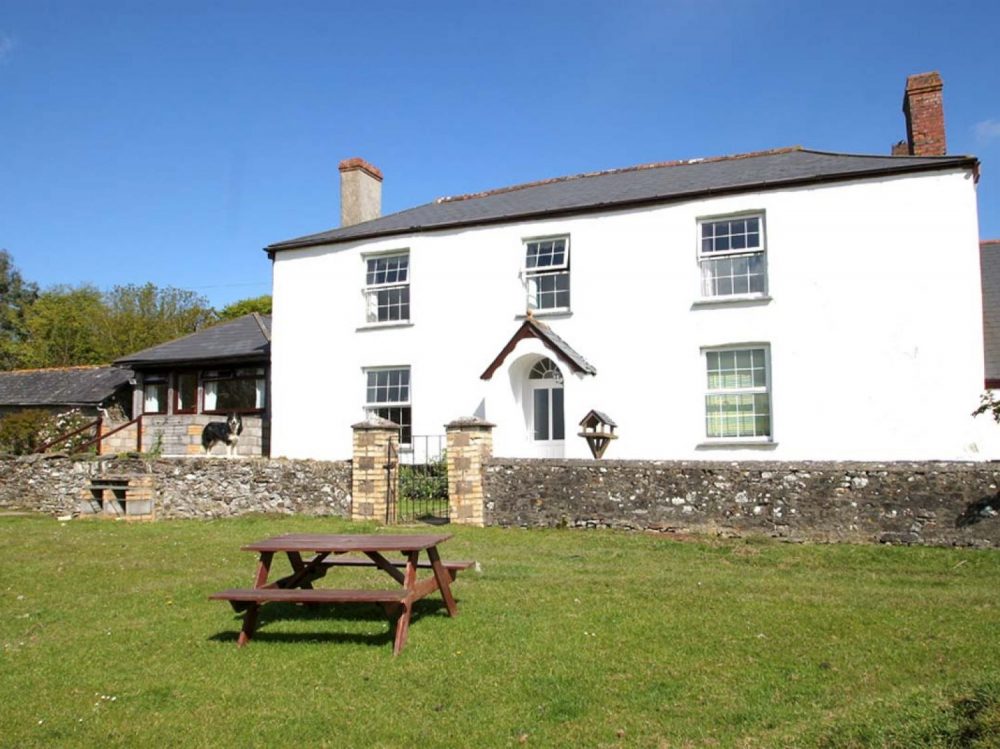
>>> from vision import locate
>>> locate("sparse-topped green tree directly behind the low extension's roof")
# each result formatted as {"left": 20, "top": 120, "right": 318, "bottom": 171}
{"left": 103, "top": 283, "right": 216, "bottom": 361}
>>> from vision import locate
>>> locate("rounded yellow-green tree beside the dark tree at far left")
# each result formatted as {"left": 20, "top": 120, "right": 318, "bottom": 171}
{"left": 18, "top": 285, "right": 107, "bottom": 367}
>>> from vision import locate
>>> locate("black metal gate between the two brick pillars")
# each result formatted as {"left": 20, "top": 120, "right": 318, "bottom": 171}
{"left": 386, "top": 434, "right": 448, "bottom": 525}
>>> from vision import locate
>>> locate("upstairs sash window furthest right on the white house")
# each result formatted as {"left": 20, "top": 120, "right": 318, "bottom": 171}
{"left": 698, "top": 215, "right": 767, "bottom": 297}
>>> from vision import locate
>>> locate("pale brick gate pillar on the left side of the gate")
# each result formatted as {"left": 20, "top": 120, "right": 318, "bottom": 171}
{"left": 351, "top": 416, "right": 399, "bottom": 523}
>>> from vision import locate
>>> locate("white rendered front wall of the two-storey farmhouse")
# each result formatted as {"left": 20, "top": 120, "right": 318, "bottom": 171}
{"left": 272, "top": 171, "right": 984, "bottom": 460}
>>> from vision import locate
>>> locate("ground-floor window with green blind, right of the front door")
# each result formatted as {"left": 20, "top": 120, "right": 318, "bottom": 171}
{"left": 705, "top": 346, "right": 771, "bottom": 439}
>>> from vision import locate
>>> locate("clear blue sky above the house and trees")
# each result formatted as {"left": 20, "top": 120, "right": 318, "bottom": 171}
{"left": 0, "top": 0, "right": 1000, "bottom": 306}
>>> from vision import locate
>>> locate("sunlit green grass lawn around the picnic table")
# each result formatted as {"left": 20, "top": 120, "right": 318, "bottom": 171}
{"left": 0, "top": 517, "right": 1000, "bottom": 749}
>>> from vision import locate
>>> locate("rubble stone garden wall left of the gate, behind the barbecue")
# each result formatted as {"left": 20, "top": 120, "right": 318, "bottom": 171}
{"left": 0, "top": 455, "right": 351, "bottom": 519}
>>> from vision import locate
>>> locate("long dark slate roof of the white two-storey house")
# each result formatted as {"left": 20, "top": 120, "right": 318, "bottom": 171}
{"left": 264, "top": 146, "right": 979, "bottom": 254}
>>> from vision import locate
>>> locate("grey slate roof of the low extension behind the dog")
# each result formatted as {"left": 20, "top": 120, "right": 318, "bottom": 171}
{"left": 115, "top": 312, "right": 271, "bottom": 368}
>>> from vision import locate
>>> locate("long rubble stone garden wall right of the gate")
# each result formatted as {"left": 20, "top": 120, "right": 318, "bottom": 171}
{"left": 485, "top": 458, "right": 1000, "bottom": 548}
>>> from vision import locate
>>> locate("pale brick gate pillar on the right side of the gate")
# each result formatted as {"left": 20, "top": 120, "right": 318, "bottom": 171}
{"left": 445, "top": 417, "right": 495, "bottom": 527}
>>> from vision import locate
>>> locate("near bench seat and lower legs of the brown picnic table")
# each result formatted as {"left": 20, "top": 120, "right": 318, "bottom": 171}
{"left": 209, "top": 587, "right": 410, "bottom": 653}
